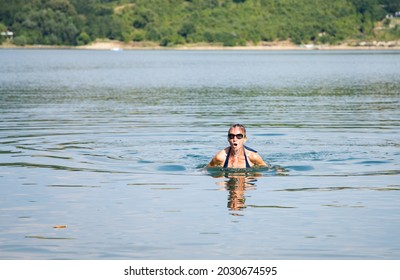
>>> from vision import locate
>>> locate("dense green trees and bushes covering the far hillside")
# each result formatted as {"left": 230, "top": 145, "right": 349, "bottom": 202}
{"left": 0, "top": 0, "right": 400, "bottom": 46}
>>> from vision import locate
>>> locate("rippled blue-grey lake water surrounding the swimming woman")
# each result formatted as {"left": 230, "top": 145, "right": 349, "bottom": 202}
{"left": 0, "top": 49, "right": 400, "bottom": 260}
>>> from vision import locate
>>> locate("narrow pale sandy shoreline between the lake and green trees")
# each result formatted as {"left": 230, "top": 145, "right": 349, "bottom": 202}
{"left": 0, "top": 40, "right": 400, "bottom": 51}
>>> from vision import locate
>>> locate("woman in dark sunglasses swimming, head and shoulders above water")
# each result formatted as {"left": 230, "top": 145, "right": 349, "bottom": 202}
{"left": 207, "top": 124, "right": 269, "bottom": 168}
